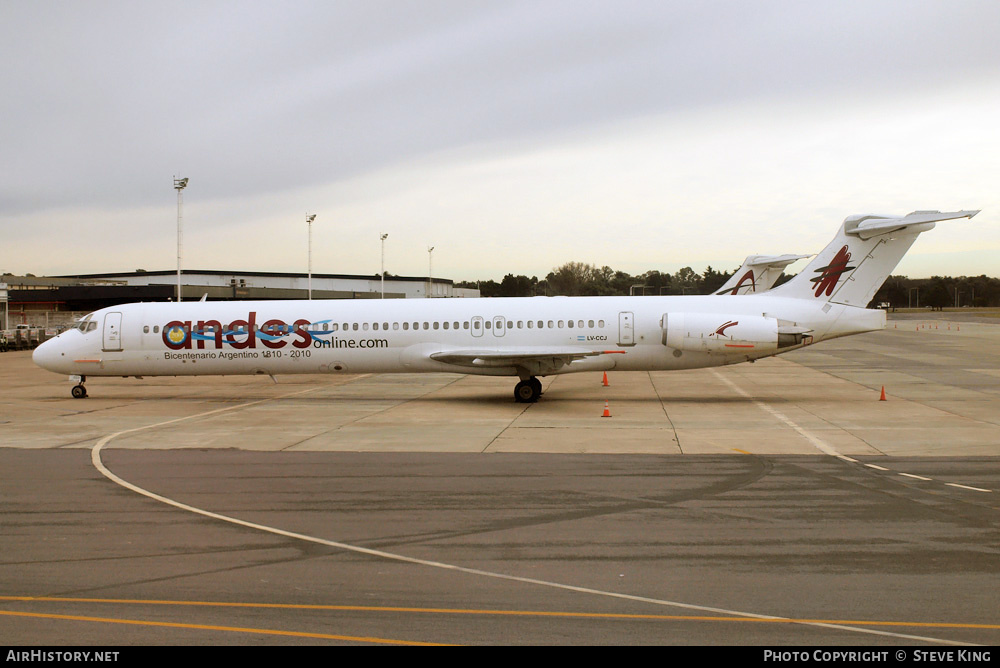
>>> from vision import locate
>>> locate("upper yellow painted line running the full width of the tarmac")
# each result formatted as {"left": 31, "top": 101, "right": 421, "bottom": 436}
{"left": 0, "top": 596, "right": 1000, "bottom": 630}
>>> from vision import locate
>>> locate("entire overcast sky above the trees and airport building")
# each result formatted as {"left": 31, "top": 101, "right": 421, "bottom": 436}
{"left": 0, "top": 0, "right": 1000, "bottom": 280}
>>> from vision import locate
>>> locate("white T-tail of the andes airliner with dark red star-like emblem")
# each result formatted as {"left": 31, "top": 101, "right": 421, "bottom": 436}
{"left": 772, "top": 211, "right": 979, "bottom": 308}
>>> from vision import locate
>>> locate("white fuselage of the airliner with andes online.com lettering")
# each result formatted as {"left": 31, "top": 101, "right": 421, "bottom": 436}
{"left": 29, "top": 295, "right": 884, "bottom": 376}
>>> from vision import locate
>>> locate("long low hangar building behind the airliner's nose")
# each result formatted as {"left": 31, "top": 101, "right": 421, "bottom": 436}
{"left": 0, "top": 270, "right": 479, "bottom": 328}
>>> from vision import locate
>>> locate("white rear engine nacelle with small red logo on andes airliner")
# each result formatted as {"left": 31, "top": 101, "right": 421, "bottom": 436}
{"left": 661, "top": 313, "right": 778, "bottom": 355}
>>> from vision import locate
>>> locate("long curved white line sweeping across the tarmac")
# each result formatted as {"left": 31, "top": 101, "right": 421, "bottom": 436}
{"left": 90, "top": 381, "right": 969, "bottom": 645}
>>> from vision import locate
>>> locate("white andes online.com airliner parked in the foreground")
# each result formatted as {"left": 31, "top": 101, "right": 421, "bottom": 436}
{"left": 33, "top": 211, "right": 979, "bottom": 403}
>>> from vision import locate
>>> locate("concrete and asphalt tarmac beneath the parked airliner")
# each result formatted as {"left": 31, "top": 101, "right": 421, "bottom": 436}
{"left": 0, "top": 319, "right": 1000, "bottom": 647}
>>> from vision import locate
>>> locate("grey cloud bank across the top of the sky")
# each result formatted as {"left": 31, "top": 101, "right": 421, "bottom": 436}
{"left": 0, "top": 1, "right": 1000, "bottom": 215}
